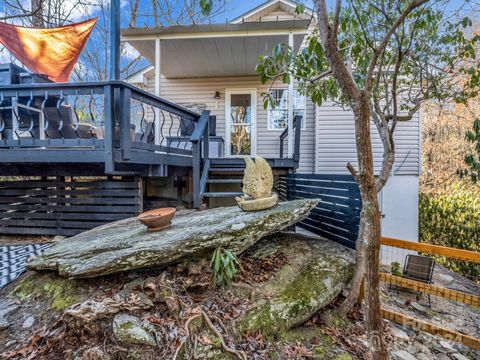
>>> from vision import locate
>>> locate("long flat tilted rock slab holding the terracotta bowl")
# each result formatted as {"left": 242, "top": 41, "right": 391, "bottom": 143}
{"left": 27, "top": 199, "right": 318, "bottom": 278}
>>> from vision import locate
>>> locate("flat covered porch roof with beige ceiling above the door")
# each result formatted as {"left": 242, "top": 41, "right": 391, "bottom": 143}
{"left": 122, "top": 20, "right": 310, "bottom": 78}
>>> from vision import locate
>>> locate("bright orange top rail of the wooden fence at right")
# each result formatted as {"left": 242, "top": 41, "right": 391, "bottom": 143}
{"left": 380, "top": 237, "right": 480, "bottom": 264}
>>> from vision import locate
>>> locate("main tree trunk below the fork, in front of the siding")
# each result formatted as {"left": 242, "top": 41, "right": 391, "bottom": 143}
{"left": 353, "top": 90, "right": 388, "bottom": 360}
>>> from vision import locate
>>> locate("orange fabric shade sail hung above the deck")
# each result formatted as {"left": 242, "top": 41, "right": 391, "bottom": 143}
{"left": 0, "top": 18, "right": 97, "bottom": 82}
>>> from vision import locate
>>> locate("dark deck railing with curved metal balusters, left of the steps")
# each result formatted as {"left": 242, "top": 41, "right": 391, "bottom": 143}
{"left": 0, "top": 81, "right": 201, "bottom": 174}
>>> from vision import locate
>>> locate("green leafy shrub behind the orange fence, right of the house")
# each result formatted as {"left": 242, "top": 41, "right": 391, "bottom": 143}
{"left": 419, "top": 185, "right": 480, "bottom": 282}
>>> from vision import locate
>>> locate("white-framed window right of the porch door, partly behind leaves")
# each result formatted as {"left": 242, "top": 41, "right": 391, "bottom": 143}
{"left": 268, "top": 89, "right": 307, "bottom": 130}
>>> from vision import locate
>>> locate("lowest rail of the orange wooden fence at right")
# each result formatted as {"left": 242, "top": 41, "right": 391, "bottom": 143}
{"left": 381, "top": 309, "right": 480, "bottom": 350}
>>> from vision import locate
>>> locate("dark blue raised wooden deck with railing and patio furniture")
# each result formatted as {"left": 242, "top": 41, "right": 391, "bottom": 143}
{"left": 0, "top": 81, "right": 301, "bottom": 205}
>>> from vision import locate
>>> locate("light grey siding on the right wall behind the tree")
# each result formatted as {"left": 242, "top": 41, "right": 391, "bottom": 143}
{"left": 315, "top": 102, "right": 420, "bottom": 175}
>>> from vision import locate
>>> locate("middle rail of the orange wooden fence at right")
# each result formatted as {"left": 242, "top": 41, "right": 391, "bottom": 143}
{"left": 380, "top": 272, "right": 480, "bottom": 307}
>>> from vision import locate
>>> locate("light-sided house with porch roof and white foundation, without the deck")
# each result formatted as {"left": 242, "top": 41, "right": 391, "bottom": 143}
{"left": 122, "top": 0, "right": 421, "bottom": 249}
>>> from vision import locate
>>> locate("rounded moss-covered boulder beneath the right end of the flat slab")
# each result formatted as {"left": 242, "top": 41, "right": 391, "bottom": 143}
{"left": 234, "top": 233, "right": 355, "bottom": 336}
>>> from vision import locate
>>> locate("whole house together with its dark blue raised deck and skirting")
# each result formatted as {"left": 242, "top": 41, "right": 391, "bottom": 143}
{"left": 0, "top": 0, "right": 421, "bottom": 253}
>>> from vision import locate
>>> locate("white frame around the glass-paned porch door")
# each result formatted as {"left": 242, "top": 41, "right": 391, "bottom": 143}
{"left": 225, "top": 88, "right": 257, "bottom": 158}
